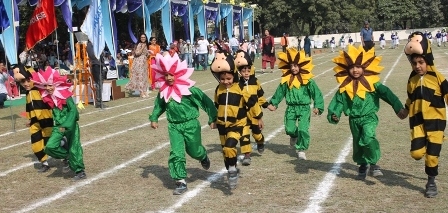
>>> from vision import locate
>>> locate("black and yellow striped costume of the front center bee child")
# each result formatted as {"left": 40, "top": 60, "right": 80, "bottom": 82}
{"left": 215, "top": 82, "right": 263, "bottom": 168}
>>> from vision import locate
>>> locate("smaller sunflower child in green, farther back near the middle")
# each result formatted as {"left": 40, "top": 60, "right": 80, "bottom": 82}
{"left": 269, "top": 48, "right": 324, "bottom": 160}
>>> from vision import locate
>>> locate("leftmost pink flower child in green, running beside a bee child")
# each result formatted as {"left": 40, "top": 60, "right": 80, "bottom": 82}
{"left": 32, "top": 67, "right": 86, "bottom": 180}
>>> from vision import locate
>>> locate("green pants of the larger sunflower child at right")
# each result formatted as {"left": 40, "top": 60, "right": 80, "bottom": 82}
{"left": 349, "top": 114, "right": 381, "bottom": 165}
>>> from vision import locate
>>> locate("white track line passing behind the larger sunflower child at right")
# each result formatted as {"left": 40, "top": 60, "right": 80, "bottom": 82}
{"left": 303, "top": 50, "right": 403, "bottom": 213}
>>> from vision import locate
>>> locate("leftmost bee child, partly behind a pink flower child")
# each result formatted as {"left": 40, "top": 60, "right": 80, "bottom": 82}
{"left": 13, "top": 64, "right": 53, "bottom": 173}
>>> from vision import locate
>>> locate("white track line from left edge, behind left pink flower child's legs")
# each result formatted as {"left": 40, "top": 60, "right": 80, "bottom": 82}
{"left": 0, "top": 78, "right": 280, "bottom": 177}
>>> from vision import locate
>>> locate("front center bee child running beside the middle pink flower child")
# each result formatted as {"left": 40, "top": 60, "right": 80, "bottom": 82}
{"left": 210, "top": 50, "right": 263, "bottom": 189}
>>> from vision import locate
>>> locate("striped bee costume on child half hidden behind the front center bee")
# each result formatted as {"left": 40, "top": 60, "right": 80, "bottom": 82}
{"left": 239, "top": 72, "right": 269, "bottom": 153}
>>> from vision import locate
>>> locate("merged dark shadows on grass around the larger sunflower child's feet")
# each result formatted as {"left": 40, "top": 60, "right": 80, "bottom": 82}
{"left": 266, "top": 144, "right": 426, "bottom": 193}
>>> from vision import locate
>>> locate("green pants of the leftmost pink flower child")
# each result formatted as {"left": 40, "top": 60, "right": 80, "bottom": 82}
{"left": 45, "top": 122, "right": 85, "bottom": 173}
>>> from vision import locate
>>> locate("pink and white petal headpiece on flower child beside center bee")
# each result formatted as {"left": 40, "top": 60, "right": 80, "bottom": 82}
{"left": 152, "top": 53, "right": 196, "bottom": 103}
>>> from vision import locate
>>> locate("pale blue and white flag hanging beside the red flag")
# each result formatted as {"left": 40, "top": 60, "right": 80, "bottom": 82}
{"left": 81, "top": 0, "right": 104, "bottom": 59}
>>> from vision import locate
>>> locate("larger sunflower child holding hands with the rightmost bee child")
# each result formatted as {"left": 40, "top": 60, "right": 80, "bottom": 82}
{"left": 327, "top": 45, "right": 405, "bottom": 180}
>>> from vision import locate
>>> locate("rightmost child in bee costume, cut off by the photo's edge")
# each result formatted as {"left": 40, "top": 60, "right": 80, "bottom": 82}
{"left": 404, "top": 32, "right": 448, "bottom": 197}
